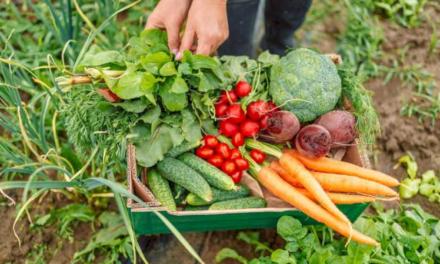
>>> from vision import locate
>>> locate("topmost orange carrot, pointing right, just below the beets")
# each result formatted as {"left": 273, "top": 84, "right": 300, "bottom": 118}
{"left": 287, "top": 150, "right": 399, "bottom": 187}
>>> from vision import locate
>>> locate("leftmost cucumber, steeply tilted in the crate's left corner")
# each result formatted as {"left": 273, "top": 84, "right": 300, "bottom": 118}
{"left": 147, "top": 169, "right": 176, "bottom": 211}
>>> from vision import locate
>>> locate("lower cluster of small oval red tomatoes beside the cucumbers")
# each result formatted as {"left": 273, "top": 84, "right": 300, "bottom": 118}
{"left": 196, "top": 135, "right": 249, "bottom": 183}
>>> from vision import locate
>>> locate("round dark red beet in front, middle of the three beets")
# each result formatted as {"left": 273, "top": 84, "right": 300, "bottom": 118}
{"left": 295, "top": 124, "right": 332, "bottom": 158}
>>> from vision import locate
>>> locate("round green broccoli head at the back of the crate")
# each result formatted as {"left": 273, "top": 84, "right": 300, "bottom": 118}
{"left": 269, "top": 48, "right": 341, "bottom": 122}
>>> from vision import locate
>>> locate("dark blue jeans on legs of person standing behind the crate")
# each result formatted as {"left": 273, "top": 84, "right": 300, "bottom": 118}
{"left": 219, "top": 0, "right": 312, "bottom": 57}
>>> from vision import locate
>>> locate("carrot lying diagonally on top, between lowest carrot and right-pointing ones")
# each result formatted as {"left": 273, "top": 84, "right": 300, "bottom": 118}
{"left": 280, "top": 154, "right": 350, "bottom": 223}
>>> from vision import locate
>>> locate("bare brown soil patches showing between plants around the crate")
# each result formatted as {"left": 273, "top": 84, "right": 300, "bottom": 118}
{"left": 0, "top": 3, "right": 440, "bottom": 264}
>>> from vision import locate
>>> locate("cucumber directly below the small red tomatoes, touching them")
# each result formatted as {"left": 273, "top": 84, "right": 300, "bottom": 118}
{"left": 178, "top": 152, "right": 236, "bottom": 191}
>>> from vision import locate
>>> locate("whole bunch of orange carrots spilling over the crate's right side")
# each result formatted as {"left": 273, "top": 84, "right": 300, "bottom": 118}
{"left": 246, "top": 140, "right": 399, "bottom": 246}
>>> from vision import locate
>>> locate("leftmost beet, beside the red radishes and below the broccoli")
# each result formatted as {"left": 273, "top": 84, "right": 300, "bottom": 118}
{"left": 260, "top": 111, "right": 300, "bottom": 143}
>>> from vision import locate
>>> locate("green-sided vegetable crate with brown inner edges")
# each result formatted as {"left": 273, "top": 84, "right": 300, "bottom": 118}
{"left": 127, "top": 145, "right": 370, "bottom": 235}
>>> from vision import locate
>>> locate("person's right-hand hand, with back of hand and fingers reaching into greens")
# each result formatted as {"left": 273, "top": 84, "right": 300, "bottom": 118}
{"left": 176, "top": 0, "right": 229, "bottom": 59}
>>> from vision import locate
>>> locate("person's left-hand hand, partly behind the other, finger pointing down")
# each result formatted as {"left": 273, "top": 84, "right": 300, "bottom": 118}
{"left": 145, "top": 0, "right": 191, "bottom": 54}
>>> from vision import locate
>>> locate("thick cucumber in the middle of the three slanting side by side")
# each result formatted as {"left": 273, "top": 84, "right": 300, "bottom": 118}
{"left": 157, "top": 157, "right": 212, "bottom": 201}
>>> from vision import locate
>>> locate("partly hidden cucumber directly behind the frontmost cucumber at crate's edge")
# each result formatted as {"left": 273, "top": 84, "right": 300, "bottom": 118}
{"left": 186, "top": 185, "right": 250, "bottom": 206}
